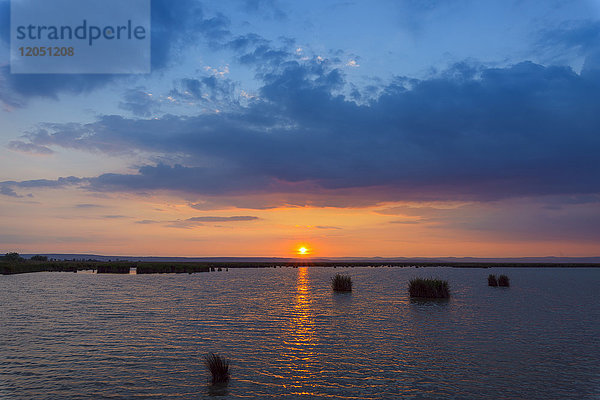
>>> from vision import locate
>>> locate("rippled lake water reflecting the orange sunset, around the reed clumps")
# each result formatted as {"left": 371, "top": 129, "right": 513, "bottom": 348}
{"left": 0, "top": 268, "right": 600, "bottom": 399}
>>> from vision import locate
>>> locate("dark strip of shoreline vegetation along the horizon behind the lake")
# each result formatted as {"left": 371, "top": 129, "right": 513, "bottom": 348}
{"left": 0, "top": 253, "right": 600, "bottom": 275}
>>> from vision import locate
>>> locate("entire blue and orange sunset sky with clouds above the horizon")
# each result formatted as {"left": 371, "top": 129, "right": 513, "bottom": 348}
{"left": 0, "top": 0, "right": 600, "bottom": 257}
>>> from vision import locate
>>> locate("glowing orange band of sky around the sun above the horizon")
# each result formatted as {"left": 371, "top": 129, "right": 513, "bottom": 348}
{"left": 0, "top": 189, "right": 598, "bottom": 257}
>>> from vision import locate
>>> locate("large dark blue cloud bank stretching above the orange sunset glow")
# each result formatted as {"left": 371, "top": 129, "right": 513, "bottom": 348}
{"left": 4, "top": 60, "right": 600, "bottom": 206}
